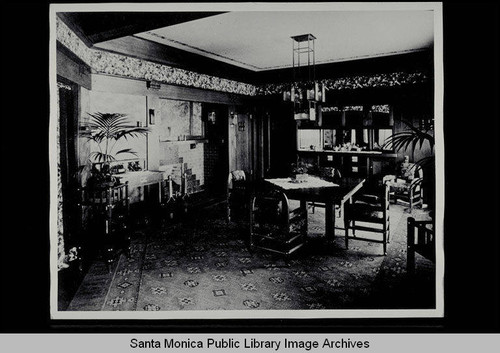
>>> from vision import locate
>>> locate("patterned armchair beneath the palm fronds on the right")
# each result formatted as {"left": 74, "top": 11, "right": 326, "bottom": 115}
{"left": 383, "top": 157, "right": 424, "bottom": 210}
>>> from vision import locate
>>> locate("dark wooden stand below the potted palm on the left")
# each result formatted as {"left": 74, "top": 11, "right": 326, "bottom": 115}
{"left": 80, "top": 182, "right": 130, "bottom": 265}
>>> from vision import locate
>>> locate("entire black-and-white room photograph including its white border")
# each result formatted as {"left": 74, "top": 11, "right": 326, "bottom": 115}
{"left": 48, "top": 2, "right": 446, "bottom": 320}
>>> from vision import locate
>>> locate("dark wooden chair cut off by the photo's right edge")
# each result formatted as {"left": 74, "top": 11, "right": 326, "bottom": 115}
{"left": 406, "top": 217, "right": 436, "bottom": 276}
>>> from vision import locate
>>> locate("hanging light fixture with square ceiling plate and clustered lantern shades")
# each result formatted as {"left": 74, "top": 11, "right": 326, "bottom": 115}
{"left": 283, "top": 33, "right": 325, "bottom": 121}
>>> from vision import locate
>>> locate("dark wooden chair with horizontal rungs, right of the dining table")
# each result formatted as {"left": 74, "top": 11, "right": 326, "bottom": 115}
{"left": 344, "top": 183, "right": 390, "bottom": 255}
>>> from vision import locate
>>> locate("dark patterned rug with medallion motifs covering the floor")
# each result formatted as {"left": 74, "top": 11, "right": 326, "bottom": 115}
{"left": 68, "top": 201, "right": 435, "bottom": 311}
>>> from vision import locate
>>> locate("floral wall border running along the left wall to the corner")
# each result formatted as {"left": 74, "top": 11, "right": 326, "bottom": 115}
{"left": 56, "top": 17, "right": 257, "bottom": 96}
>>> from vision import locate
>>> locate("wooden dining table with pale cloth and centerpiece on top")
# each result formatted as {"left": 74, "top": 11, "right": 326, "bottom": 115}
{"left": 264, "top": 176, "right": 365, "bottom": 238}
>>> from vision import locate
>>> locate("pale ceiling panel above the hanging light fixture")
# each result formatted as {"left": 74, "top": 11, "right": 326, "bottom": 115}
{"left": 136, "top": 10, "right": 434, "bottom": 71}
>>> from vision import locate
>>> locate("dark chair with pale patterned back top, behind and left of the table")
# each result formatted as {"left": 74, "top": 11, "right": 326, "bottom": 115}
{"left": 227, "top": 170, "right": 249, "bottom": 222}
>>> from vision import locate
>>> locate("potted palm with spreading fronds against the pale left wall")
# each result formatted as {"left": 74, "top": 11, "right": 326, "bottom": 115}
{"left": 80, "top": 112, "right": 149, "bottom": 188}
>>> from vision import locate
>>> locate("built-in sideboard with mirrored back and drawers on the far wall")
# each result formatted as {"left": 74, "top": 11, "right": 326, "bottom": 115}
{"left": 297, "top": 105, "right": 397, "bottom": 176}
